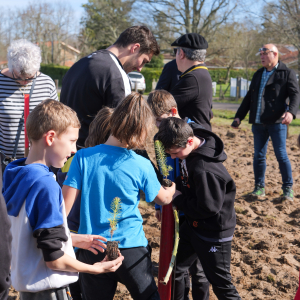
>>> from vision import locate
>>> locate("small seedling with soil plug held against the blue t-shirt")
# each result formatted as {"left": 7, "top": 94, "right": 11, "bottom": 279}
{"left": 106, "top": 197, "right": 121, "bottom": 260}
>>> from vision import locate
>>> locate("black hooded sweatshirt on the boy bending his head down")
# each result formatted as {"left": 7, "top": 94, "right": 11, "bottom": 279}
{"left": 173, "top": 124, "right": 236, "bottom": 239}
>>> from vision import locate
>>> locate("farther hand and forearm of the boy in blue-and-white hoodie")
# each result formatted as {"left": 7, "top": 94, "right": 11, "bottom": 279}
{"left": 71, "top": 233, "right": 107, "bottom": 255}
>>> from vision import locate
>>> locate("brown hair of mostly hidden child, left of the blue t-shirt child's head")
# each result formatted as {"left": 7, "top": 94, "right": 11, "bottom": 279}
{"left": 84, "top": 107, "right": 114, "bottom": 148}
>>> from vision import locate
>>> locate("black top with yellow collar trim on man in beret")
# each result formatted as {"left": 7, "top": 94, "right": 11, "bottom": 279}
{"left": 171, "top": 64, "right": 212, "bottom": 130}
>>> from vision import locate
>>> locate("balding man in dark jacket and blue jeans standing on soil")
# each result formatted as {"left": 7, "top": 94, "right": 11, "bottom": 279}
{"left": 235, "top": 44, "right": 300, "bottom": 201}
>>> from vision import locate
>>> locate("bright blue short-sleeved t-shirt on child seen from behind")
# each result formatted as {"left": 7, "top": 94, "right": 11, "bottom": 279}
{"left": 64, "top": 145, "right": 161, "bottom": 248}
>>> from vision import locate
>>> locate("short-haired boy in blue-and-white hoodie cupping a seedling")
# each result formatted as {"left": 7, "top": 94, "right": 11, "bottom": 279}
{"left": 3, "top": 99, "right": 123, "bottom": 300}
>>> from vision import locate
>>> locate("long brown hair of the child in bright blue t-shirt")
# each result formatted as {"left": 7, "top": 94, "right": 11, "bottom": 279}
{"left": 110, "top": 92, "right": 154, "bottom": 149}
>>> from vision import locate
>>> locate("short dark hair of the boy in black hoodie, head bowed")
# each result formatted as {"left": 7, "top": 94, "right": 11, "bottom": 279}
{"left": 155, "top": 117, "right": 194, "bottom": 150}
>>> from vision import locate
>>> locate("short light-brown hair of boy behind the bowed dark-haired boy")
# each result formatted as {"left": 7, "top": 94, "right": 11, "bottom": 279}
{"left": 147, "top": 90, "right": 177, "bottom": 118}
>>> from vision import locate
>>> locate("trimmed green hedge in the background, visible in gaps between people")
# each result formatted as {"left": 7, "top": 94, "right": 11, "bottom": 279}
{"left": 41, "top": 64, "right": 255, "bottom": 92}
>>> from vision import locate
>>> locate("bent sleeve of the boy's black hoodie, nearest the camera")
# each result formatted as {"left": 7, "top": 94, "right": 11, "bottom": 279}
{"left": 173, "top": 172, "right": 226, "bottom": 219}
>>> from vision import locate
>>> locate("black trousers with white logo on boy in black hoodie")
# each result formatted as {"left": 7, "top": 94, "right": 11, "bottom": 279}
{"left": 174, "top": 221, "right": 241, "bottom": 300}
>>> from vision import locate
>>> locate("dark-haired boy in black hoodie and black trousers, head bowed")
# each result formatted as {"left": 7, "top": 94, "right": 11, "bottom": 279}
{"left": 156, "top": 118, "right": 241, "bottom": 300}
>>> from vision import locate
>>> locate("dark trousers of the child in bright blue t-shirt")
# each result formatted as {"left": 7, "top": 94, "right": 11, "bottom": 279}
{"left": 79, "top": 246, "right": 160, "bottom": 300}
